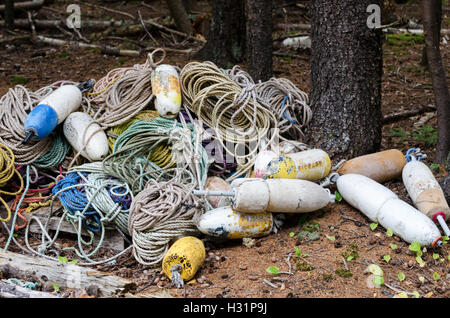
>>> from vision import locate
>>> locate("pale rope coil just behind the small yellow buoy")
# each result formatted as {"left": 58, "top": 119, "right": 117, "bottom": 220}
{"left": 128, "top": 180, "right": 202, "bottom": 265}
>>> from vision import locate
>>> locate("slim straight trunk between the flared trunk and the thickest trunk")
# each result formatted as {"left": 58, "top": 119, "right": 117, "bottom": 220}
{"left": 246, "top": 0, "right": 272, "bottom": 82}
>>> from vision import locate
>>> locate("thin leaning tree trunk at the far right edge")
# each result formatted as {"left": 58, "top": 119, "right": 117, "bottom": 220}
{"left": 423, "top": 0, "right": 450, "bottom": 165}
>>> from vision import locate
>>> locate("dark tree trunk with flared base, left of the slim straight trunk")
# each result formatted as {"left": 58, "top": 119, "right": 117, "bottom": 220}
{"left": 196, "top": 0, "right": 245, "bottom": 68}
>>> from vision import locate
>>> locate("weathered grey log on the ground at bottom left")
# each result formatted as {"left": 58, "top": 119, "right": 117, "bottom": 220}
{"left": 0, "top": 250, "right": 136, "bottom": 296}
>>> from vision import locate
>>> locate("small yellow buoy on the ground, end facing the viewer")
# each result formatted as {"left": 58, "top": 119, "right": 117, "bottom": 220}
{"left": 162, "top": 236, "right": 206, "bottom": 288}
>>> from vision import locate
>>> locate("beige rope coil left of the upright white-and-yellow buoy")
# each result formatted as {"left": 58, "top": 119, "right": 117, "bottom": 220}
{"left": 88, "top": 49, "right": 165, "bottom": 128}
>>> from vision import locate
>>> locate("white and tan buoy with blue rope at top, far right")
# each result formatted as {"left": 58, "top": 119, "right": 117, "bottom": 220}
{"left": 402, "top": 148, "right": 450, "bottom": 236}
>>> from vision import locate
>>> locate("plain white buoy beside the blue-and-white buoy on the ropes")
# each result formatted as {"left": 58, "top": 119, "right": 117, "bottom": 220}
{"left": 63, "top": 112, "right": 109, "bottom": 161}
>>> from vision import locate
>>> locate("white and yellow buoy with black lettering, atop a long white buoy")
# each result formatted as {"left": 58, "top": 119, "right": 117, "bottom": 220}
{"left": 264, "top": 149, "right": 331, "bottom": 181}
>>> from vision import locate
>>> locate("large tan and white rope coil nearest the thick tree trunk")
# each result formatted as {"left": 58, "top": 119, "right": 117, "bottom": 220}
{"left": 181, "top": 62, "right": 278, "bottom": 180}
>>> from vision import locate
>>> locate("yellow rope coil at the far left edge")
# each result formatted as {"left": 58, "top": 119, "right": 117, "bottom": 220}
{"left": 0, "top": 143, "right": 23, "bottom": 222}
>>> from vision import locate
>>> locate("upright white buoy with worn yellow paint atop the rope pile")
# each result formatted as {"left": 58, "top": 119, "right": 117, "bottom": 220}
{"left": 151, "top": 64, "right": 181, "bottom": 118}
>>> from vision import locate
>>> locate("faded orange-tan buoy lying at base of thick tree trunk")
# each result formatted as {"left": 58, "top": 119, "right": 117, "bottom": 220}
{"left": 337, "top": 149, "right": 406, "bottom": 183}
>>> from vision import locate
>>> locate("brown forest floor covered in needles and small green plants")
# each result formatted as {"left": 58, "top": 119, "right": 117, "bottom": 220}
{"left": 0, "top": 1, "right": 450, "bottom": 298}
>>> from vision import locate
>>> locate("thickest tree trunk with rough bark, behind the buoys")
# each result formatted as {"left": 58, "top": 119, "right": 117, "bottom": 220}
{"left": 307, "top": 0, "right": 383, "bottom": 158}
